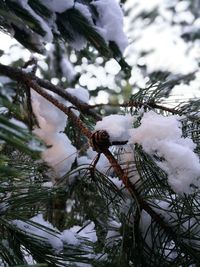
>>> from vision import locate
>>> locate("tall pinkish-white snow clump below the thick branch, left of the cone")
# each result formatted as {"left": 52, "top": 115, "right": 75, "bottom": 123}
{"left": 31, "top": 91, "right": 77, "bottom": 180}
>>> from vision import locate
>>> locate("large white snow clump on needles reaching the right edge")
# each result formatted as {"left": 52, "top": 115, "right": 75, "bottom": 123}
{"left": 129, "top": 111, "right": 200, "bottom": 194}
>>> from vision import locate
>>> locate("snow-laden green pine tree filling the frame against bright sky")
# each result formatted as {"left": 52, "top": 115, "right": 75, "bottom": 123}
{"left": 0, "top": 0, "right": 200, "bottom": 267}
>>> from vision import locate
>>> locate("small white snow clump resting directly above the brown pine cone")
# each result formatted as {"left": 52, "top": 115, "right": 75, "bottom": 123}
{"left": 95, "top": 115, "right": 133, "bottom": 142}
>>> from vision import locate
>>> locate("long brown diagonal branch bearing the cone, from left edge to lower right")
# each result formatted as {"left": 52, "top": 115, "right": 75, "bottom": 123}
{"left": 0, "top": 64, "right": 200, "bottom": 262}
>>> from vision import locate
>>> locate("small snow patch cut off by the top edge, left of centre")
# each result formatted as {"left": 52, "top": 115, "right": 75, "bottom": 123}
{"left": 40, "top": 0, "right": 74, "bottom": 13}
